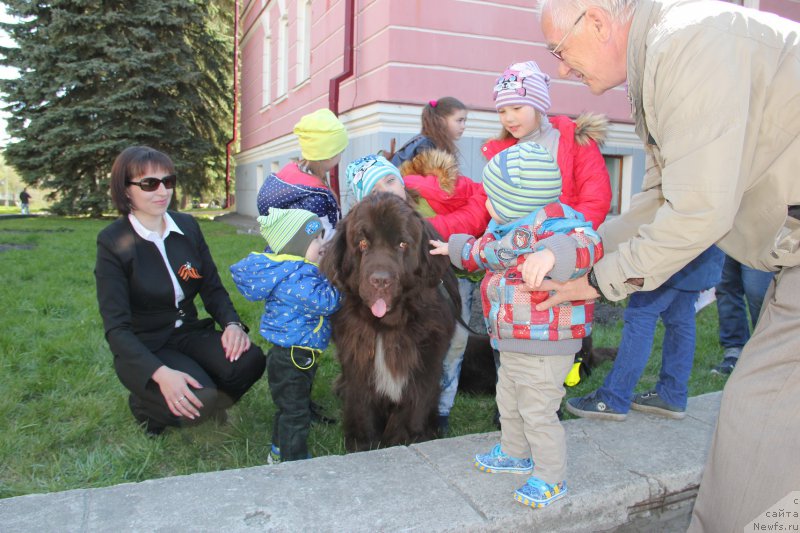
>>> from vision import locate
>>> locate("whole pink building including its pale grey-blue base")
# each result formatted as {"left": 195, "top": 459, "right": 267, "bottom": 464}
{"left": 236, "top": 0, "right": 800, "bottom": 215}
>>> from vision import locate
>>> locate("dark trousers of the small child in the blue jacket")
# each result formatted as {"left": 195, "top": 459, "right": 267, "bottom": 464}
{"left": 267, "top": 346, "right": 319, "bottom": 461}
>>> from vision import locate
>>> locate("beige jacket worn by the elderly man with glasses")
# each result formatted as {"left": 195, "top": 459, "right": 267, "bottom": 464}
{"left": 595, "top": 0, "right": 800, "bottom": 300}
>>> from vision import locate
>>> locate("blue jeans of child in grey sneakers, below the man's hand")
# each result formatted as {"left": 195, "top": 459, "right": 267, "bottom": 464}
{"left": 597, "top": 286, "right": 700, "bottom": 413}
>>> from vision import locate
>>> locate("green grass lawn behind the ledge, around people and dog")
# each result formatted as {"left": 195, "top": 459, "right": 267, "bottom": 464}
{"left": 0, "top": 216, "right": 725, "bottom": 498}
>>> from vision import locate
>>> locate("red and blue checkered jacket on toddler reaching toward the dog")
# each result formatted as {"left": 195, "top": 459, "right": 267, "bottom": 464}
{"left": 449, "top": 202, "right": 603, "bottom": 355}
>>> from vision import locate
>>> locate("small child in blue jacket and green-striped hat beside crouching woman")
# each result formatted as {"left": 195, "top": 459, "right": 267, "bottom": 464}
{"left": 231, "top": 207, "right": 341, "bottom": 463}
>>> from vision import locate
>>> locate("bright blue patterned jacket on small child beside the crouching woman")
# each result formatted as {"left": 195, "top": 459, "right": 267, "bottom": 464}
{"left": 231, "top": 252, "right": 341, "bottom": 350}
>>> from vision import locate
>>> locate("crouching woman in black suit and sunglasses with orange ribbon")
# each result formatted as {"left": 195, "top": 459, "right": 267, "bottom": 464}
{"left": 95, "top": 146, "right": 266, "bottom": 435}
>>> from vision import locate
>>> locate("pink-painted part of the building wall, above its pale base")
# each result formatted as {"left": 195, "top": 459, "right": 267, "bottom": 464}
{"left": 241, "top": 0, "right": 630, "bottom": 151}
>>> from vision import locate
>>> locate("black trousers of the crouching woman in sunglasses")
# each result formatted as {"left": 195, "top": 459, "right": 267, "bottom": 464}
{"left": 120, "top": 327, "right": 266, "bottom": 429}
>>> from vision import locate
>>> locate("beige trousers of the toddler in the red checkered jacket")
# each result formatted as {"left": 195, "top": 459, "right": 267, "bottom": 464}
{"left": 497, "top": 352, "right": 575, "bottom": 485}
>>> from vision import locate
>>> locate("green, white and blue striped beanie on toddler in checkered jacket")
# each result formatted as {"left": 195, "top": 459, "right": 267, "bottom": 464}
{"left": 483, "top": 142, "right": 561, "bottom": 223}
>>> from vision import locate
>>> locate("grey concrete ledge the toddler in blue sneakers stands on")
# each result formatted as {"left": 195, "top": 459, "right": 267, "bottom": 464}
{"left": 0, "top": 393, "right": 721, "bottom": 533}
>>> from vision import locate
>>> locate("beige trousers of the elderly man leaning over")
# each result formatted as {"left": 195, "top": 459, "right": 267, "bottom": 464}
{"left": 689, "top": 267, "right": 800, "bottom": 533}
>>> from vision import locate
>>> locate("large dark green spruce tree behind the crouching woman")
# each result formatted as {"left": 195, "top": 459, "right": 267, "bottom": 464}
{"left": 0, "top": 0, "right": 233, "bottom": 216}
